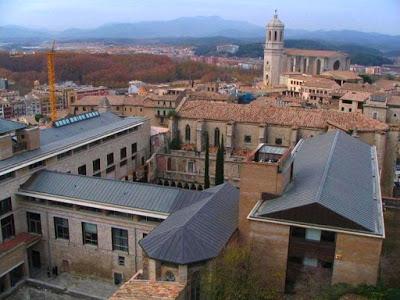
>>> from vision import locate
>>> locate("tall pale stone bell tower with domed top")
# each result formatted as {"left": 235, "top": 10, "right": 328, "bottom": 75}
{"left": 263, "top": 10, "right": 285, "bottom": 86}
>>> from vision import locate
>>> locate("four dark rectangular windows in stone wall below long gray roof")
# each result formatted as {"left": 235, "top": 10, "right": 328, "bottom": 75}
{"left": 26, "top": 212, "right": 129, "bottom": 252}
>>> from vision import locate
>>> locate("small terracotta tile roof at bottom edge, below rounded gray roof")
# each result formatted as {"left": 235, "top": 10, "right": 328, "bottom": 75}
{"left": 109, "top": 278, "right": 185, "bottom": 300}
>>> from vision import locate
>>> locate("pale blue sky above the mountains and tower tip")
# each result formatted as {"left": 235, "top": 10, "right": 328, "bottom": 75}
{"left": 0, "top": 0, "right": 400, "bottom": 35}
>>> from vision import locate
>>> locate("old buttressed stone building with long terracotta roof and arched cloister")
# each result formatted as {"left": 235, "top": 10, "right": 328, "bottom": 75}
{"left": 152, "top": 101, "right": 398, "bottom": 195}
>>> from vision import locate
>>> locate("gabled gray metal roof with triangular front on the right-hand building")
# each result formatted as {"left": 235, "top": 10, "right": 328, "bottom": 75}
{"left": 254, "top": 131, "right": 383, "bottom": 235}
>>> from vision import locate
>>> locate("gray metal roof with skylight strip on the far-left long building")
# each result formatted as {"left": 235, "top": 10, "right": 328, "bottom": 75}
{"left": 0, "top": 112, "right": 145, "bottom": 173}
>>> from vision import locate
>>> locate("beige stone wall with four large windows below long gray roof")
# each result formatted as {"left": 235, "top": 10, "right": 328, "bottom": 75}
{"left": 18, "top": 198, "right": 159, "bottom": 279}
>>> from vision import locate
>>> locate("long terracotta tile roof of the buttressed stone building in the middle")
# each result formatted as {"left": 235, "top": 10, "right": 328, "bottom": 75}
{"left": 178, "top": 101, "right": 388, "bottom": 131}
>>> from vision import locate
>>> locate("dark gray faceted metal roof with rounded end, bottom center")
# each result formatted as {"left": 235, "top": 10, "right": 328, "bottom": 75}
{"left": 139, "top": 183, "right": 239, "bottom": 264}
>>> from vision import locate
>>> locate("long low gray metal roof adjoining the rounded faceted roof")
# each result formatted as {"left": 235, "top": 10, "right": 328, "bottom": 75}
{"left": 19, "top": 170, "right": 207, "bottom": 214}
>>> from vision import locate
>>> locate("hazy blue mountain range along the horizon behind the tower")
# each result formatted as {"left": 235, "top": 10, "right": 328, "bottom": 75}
{"left": 0, "top": 17, "right": 400, "bottom": 51}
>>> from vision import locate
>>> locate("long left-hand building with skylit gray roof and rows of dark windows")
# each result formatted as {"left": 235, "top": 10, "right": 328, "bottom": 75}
{"left": 0, "top": 112, "right": 150, "bottom": 296}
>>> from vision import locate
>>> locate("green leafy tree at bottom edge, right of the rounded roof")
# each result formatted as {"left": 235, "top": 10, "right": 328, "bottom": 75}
{"left": 200, "top": 245, "right": 277, "bottom": 300}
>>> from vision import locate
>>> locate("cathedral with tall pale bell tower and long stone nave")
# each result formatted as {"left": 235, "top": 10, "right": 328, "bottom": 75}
{"left": 263, "top": 11, "right": 350, "bottom": 86}
